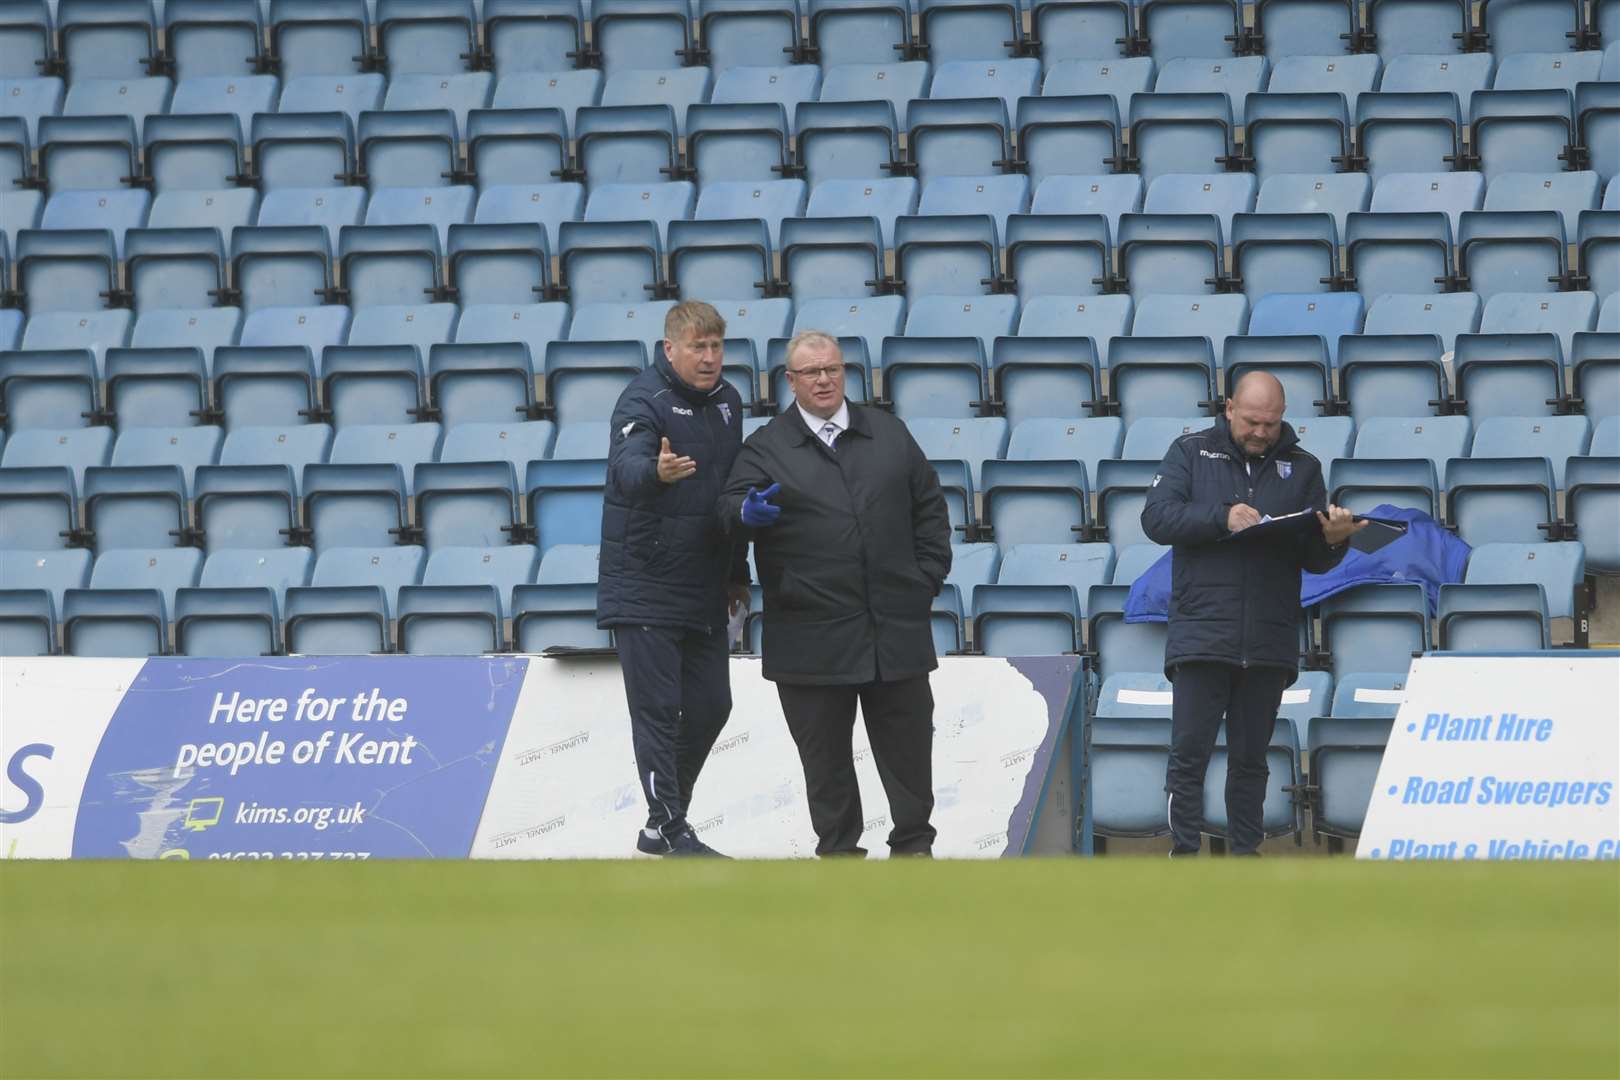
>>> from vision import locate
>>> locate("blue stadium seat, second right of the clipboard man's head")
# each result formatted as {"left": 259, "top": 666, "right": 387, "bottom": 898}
{"left": 1450, "top": 334, "right": 1565, "bottom": 424}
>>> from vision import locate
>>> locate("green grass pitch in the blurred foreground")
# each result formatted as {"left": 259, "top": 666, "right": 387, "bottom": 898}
{"left": 0, "top": 858, "right": 1620, "bottom": 1078}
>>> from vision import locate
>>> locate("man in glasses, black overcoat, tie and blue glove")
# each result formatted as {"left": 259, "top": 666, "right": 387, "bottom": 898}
{"left": 719, "top": 330, "right": 951, "bottom": 855}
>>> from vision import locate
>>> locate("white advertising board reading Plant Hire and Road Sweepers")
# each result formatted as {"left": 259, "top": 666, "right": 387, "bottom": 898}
{"left": 1356, "top": 654, "right": 1620, "bottom": 860}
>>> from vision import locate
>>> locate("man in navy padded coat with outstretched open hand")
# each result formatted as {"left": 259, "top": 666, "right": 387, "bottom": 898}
{"left": 596, "top": 300, "right": 748, "bottom": 855}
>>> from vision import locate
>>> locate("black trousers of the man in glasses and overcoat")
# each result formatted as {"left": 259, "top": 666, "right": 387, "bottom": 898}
{"left": 776, "top": 675, "right": 935, "bottom": 855}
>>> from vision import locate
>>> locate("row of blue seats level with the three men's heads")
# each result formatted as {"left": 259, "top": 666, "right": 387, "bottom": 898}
{"left": 9, "top": 325, "right": 1620, "bottom": 440}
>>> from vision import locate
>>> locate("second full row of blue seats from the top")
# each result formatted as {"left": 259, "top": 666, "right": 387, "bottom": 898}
{"left": 0, "top": 67, "right": 1620, "bottom": 191}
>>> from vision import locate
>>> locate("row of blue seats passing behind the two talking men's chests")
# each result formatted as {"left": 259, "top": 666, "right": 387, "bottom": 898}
{"left": 0, "top": 416, "right": 1620, "bottom": 573}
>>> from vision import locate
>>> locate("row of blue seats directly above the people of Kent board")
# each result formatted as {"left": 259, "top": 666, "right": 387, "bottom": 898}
{"left": 0, "top": 534, "right": 1594, "bottom": 667}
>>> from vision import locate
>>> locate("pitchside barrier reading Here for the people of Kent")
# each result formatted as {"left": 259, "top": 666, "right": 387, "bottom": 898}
{"left": 0, "top": 656, "right": 1085, "bottom": 860}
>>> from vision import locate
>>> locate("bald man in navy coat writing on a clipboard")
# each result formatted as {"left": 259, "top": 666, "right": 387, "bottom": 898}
{"left": 1142, "top": 371, "right": 1366, "bottom": 855}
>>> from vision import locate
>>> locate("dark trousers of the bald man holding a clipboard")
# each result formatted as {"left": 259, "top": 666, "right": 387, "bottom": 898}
{"left": 1165, "top": 662, "right": 1291, "bottom": 855}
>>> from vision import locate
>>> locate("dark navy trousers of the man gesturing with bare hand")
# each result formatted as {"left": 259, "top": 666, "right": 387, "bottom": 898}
{"left": 614, "top": 627, "right": 731, "bottom": 837}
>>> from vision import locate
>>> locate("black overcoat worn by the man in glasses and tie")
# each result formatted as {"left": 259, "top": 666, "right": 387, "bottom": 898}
{"left": 718, "top": 403, "right": 951, "bottom": 685}
